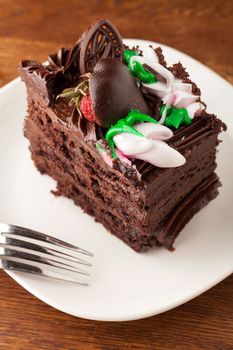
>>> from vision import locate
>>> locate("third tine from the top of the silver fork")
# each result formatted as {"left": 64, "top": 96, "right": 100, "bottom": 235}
{"left": 0, "top": 244, "right": 90, "bottom": 276}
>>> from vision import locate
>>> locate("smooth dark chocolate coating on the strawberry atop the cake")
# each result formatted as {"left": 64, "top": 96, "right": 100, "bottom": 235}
{"left": 89, "top": 58, "right": 151, "bottom": 128}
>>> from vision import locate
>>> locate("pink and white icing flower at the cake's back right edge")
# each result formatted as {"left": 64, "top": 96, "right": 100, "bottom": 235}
{"left": 130, "top": 47, "right": 205, "bottom": 124}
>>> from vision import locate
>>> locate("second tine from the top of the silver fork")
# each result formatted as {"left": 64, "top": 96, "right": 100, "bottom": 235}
{"left": 0, "top": 238, "right": 91, "bottom": 266}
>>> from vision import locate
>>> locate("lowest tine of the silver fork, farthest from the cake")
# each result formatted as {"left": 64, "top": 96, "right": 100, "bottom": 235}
{"left": 0, "top": 257, "right": 88, "bottom": 286}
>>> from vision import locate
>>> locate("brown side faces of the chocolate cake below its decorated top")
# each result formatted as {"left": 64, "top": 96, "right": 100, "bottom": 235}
{"left": 25, "top": 89, "right": 222, "bottom": 251}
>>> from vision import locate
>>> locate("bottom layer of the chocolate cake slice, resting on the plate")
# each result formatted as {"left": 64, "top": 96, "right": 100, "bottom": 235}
{"left": 24, "top": 114, "right": 219, "bottom": 251}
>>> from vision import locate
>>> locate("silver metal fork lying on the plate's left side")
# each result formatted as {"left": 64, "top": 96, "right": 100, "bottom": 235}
{"left": 0, "top": 223, "right": 93, "bottom": 285}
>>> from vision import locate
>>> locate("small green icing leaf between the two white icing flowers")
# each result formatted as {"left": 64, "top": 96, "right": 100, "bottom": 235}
{"left": 160, "top": 105, "right": 192, "bottom": 129}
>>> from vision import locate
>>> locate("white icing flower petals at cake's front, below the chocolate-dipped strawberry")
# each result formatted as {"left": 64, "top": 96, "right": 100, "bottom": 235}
{"left": 113, "top": 122, "right": 186, "bottom": 168}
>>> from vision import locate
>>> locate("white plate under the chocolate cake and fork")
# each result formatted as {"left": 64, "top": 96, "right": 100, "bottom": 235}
{"left": 0, "top": 40, "right": 233, "bottom": 321}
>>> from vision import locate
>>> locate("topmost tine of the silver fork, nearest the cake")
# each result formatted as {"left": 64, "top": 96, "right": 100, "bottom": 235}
{"left": 0, "top": 224, "right": 93, "bottom": 256}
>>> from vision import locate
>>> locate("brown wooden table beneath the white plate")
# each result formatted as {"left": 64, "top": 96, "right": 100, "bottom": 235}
{"left": 0, "top": 0, "right": 233, "bottom": 350}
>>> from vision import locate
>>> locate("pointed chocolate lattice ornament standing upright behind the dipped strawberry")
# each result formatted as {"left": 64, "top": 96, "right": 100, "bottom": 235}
{"left": 80, "top": 19, "right": 123, "bottom": 74}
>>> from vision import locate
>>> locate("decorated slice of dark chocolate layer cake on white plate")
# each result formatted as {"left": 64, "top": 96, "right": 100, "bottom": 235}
{"left": 19, "top": 19, "right": 226, "bottom": 251}
